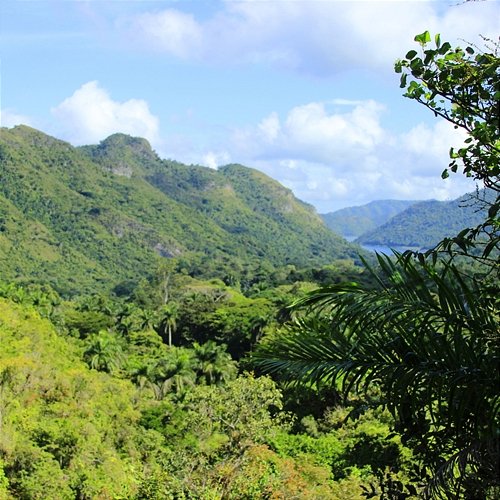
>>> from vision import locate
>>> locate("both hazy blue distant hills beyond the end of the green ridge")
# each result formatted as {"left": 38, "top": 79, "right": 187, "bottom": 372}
{"left": 321, "top": 190, "right": 493, "bottom": 249}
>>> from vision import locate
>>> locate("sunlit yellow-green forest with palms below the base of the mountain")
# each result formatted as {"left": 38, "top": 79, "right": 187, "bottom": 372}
{"left": 0, "top": 282, "right": 418, "bottom": 500}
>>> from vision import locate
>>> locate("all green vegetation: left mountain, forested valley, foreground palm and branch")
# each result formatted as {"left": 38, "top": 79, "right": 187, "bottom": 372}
{"left": 0, "top": 28, "right": 500, "bottom": 500}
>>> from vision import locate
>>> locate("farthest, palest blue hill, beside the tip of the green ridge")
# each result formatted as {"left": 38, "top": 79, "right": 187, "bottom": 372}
{"left": 321, "top": 200, "right": 417, "bottom": 238}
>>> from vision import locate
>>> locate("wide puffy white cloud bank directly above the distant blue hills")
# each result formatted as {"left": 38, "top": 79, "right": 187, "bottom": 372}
{"left": 223, "top": 100, "right": 474, "bottom": 212}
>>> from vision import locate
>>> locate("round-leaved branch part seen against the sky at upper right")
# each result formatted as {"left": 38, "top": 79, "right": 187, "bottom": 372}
{"left": 395, "top": 31, "right": 500, "bottom": 191}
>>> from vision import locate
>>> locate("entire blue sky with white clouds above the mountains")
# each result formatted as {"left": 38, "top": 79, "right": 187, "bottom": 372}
{"left": 0, "top": 0, "right": 500, "bottom": 213}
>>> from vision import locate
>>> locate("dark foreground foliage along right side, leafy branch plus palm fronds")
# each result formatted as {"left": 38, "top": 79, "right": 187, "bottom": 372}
{"left": 255, "top": 32, "right": 500, "bottom": 498}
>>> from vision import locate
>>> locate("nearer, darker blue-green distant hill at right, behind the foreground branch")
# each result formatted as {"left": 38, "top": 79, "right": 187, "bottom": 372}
{"left": 356, "top": 190, "right": 492, "bottom": 248}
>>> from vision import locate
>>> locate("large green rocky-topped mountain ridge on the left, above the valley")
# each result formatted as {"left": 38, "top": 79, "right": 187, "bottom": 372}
{"left": 0, "top": 126, "right": 359, "bottom": 294}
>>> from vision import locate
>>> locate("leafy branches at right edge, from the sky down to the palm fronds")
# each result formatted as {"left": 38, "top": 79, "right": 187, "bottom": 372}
{"left": 395, "top": 31, "right": 500, "bottom": 271}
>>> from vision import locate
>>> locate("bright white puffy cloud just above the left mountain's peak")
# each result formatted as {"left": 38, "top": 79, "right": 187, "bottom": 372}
{"left": 51, "top": 81, "right": 159, "bottom": 145}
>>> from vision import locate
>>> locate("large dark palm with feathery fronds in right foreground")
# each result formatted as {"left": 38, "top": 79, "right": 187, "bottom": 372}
{"left": 254, "top": 255, "right": 500, "bottom": 498}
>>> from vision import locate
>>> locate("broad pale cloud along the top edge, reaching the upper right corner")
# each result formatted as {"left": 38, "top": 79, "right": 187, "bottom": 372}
{"left": 129, "top": 0, "right": 500, "bottom": 75}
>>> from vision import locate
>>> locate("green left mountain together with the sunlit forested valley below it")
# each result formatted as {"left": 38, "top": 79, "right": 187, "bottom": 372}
{"left": 0, "top": 126, "right": 422, "bottom": 500}
